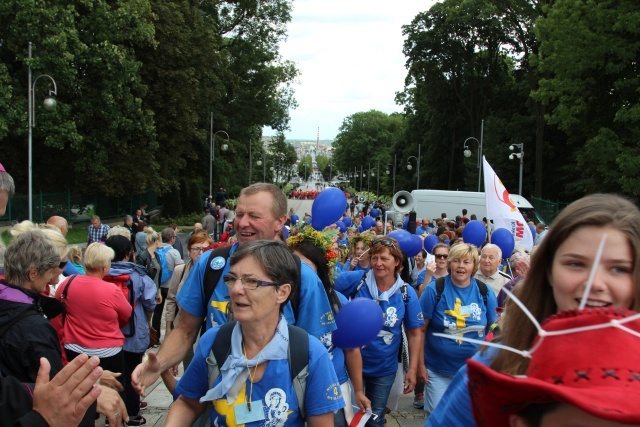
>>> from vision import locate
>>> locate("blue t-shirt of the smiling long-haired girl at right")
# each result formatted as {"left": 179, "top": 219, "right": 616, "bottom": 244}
{"left": 425, "top": 348, "right": 499, "bottom": 427}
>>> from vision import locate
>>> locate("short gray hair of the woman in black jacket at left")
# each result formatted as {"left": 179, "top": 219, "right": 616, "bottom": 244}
{"left": 4, "top": 229, "right": 60, "bottom": 286}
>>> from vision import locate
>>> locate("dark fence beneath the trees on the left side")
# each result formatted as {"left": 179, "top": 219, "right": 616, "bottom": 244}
{"left": 0, "top": 190, "right": 158, "bottom": 224}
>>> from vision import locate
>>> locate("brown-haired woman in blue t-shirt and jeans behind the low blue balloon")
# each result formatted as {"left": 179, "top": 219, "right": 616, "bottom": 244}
{"left": 335, "top": 237, "right": 424, "bottom": 426}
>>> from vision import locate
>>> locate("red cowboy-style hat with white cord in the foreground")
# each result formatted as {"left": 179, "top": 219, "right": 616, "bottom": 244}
{"left": 467, "top": 309, "right": 640, "bottom": 427}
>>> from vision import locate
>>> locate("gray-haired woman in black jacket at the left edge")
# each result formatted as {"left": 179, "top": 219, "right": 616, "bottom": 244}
{"left": 0, "top": 229, "right": 126, "bottom": 426}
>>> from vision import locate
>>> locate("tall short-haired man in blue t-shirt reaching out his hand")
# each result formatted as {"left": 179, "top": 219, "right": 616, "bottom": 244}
{"left": 132, "top": 183, "right": 336, "bottom": 395}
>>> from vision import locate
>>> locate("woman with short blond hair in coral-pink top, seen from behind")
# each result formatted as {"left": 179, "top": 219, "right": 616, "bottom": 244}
{"left": 56, "top": 243, "right": 131, "bottom": 384}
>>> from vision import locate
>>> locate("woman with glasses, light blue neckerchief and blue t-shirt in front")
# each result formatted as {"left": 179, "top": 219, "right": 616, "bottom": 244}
{"left": 166, "top": 240, "right": 344, "bottom": 427}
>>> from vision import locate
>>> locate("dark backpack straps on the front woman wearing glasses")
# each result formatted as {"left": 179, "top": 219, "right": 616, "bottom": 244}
{"left": 200, "top": 321, "right": 309, "bottom": 425}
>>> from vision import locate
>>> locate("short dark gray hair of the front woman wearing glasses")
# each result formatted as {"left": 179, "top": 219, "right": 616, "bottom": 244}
{"left": 229, "top": 240, "right": 300, "bottom": 311}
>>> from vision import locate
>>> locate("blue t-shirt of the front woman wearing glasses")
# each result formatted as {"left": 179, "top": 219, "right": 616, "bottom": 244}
{"left": 174, "top": 328, "right": 344, "bottom": 427}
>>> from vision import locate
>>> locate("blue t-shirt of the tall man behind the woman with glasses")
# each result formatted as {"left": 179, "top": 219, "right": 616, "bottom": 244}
{"left": 176, "top": 243, "right": 336, "bottom": 338}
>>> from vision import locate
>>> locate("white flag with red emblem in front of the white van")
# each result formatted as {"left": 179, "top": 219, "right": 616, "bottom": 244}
{"left": 482, "top": 156, "right": 533, "bottom": 251}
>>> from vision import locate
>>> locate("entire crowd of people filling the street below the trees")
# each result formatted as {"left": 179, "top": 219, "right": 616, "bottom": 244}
{"left": 0, "top": 159, "right": 640, "bottom": 426}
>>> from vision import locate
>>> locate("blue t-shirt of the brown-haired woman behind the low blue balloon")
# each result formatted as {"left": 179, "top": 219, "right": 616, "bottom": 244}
{"left": 335, "top": 271, "right": 424, "bottom": 377}
